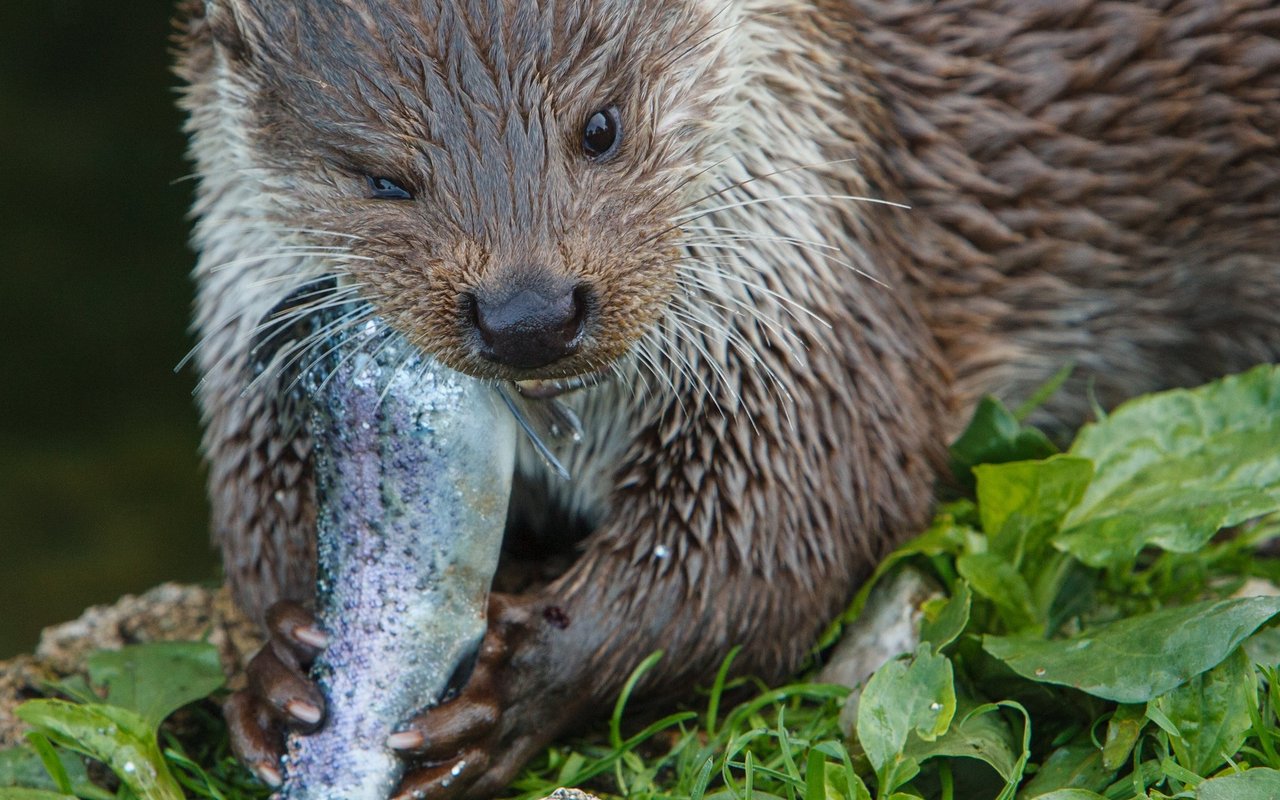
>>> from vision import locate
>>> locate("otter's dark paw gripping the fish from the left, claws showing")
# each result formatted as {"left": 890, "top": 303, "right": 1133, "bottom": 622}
{"left": 223, "top": 602, "right": 326, "bottom": 787}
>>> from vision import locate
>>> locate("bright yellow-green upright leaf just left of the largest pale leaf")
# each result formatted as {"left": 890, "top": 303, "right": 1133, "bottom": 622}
{"left": 973, "top": 456, "right": 1093, "bottom": 567}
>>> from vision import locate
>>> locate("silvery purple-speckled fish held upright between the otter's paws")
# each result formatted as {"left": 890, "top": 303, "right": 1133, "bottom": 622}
{"left": 280, "top": 308, "right": 517, "bottom": 800}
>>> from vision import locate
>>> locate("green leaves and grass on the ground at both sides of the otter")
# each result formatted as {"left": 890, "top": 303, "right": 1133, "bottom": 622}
{"left": 0, "top": 366, "right": 1280, "bottom": 800}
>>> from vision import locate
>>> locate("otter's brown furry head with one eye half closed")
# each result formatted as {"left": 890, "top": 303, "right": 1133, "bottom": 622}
{"left": 186, "top": 0, "right": 733, "bottom": 380}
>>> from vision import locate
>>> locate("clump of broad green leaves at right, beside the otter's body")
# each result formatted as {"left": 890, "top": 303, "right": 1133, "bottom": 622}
{"left": 856, "top": 366, "right": 1280, "bottom": 800}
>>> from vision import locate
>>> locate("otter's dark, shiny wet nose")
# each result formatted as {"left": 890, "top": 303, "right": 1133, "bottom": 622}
{"left": 467, "top": 280, "right": 586, "bottom": 370}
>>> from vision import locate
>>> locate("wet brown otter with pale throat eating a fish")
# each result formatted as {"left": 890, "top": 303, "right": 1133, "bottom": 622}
{"left": 178, "top": 0, "right": 1280, "bottom": 799}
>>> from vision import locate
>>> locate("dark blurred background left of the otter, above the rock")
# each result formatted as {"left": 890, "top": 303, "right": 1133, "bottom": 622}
{"left": 0, "top": 0, "right": 218, "bottom": 658}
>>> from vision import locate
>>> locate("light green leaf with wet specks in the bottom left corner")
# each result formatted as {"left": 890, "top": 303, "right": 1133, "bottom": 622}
{"left": 15, "top": 700, "right": 183, "bottom": 800}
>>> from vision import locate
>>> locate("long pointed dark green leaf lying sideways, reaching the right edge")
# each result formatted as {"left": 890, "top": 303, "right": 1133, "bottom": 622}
{"left": 983, "top": 598, "right": 1280, "bottom": 703}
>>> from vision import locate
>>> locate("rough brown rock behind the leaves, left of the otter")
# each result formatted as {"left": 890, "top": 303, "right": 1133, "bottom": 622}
{"left": 0, "top": 584, "right": 262, "bottom": 749}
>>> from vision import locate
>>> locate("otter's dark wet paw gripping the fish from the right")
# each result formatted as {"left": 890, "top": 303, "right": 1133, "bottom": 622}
{"left": 388, "top": 594, "right": 575, "bottom": 800}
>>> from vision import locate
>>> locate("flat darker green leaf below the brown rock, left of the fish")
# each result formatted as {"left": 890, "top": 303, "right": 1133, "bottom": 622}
{"left": 88, "top": 641, "right": 225, "bottom": 728}
